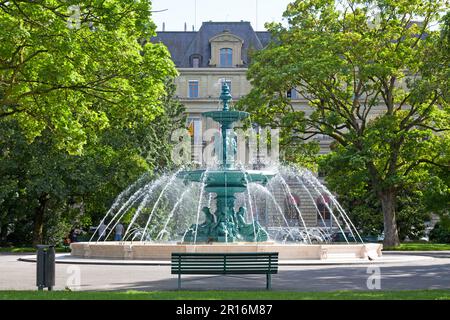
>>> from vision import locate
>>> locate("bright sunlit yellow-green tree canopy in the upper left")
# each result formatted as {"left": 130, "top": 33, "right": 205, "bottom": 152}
{"left": 0, "top": 0, "right": 176, "bottom": 154}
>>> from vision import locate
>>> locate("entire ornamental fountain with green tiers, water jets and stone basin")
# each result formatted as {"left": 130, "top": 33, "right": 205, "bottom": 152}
{"left": 71, "top": 83, "right": 382, "bottom": 261}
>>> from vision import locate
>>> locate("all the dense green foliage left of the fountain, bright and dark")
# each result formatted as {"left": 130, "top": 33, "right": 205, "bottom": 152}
{"left": 0, "top": 0, "right": 183, "bottom": 243}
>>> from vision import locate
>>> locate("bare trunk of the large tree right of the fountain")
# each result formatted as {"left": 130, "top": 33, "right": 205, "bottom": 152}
{"left": 379, "top": 190, "right": 400, "bottom": 247}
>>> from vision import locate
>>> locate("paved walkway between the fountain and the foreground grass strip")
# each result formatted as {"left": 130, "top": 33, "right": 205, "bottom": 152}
{"left": 0, "top": 252, "right": 450, "bottom": 291}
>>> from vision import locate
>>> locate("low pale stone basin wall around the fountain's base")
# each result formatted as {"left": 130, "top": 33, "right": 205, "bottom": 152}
{"left": 70, "top": 241, "right": 382, "bottom": 260}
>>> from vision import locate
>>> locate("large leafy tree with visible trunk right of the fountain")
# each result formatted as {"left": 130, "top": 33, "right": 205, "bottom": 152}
{"left": 241, "top": 0, "right": 450, "bottom": 246}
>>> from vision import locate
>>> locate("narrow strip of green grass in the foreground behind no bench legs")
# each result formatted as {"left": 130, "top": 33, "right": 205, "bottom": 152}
{"left": 0, "top": 290, "right": 450, "bottom": 300}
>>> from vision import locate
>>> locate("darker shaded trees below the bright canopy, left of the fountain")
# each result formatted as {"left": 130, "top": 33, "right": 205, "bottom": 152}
{"left": 0, "top": 82, "right": 183, "bottom": 244}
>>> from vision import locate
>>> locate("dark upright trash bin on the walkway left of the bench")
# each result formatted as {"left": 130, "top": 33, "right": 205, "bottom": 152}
{"left": 36, "top": 245, "right": 55, "bottom": 290}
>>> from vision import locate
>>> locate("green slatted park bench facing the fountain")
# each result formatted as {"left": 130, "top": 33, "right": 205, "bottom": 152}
{"left": 172, "top": 252, "right": 278, "bottom": 290}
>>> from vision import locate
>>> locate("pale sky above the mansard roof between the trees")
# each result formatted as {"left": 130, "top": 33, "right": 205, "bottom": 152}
{"left": 152, "top": 0, "right": 293, "bottom": 31}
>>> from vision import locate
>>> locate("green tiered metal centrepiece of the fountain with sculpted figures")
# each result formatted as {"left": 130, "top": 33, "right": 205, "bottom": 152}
{"left": 178, "top": 83, "right": 273, "bottom": 243}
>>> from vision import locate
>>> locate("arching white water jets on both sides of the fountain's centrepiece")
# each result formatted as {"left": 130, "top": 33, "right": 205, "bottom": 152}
{"left": 91, "top": 166, "right": 362, "bottom": 244}
